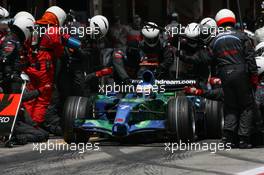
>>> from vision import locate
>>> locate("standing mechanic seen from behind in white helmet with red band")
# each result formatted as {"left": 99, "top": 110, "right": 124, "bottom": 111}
{"left": 210, "top": 9, "right": 258, "bottom": 148}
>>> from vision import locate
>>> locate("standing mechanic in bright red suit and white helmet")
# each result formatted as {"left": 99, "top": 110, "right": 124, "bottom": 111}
{"left": 24, "top": 6, "right": 68, "bottom": 126}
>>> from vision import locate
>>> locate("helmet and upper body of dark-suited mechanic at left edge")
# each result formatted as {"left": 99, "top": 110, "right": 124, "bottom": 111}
{"left": 0, "top": 14, "right": 35, "bottom": 93}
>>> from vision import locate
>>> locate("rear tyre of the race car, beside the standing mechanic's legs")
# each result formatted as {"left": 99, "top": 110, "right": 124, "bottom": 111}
{"left": 205, "top": 100, "right": 224, "bottom": 139}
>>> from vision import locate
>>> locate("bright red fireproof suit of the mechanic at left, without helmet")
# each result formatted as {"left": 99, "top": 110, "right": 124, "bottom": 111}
{"left": 24, "top": 27, "right": 64, "bottom": 124}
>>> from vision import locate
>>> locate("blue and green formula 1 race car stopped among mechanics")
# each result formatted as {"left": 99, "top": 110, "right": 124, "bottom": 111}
{"left": 64, "top": 71, "right": 225, "bottom": 143}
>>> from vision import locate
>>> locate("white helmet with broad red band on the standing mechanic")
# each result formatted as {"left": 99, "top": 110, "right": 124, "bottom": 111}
{"left": 215, "top": 9, "right": 236, "bottom": 26}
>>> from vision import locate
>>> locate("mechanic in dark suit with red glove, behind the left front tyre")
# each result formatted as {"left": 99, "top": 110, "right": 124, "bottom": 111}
{"left": 75, "top": 15, "right": 112, "bottom": 97}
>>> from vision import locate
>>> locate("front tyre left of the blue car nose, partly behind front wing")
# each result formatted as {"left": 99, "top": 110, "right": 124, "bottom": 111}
{"left": 63, "top": 97, "right": 92, "bottom": 144}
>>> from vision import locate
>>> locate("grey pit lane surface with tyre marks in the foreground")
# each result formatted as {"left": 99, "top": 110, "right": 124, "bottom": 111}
{"left": 0, "top": 139, "right": 264, "bottom": 175}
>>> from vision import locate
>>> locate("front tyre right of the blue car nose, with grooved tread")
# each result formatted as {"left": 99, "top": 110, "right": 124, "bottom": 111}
{"left": 167, "top": 96, "right": 196, "bottom": 142}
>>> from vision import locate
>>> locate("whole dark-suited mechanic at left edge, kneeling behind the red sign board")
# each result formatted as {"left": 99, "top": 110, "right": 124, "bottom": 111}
{"left": 0, "top": 13, "right": 48, "bottom": 144}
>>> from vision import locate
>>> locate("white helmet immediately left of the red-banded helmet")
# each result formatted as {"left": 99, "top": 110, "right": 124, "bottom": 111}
{"left": 200, "top": 18, "right": 217, "bottom": 43}
